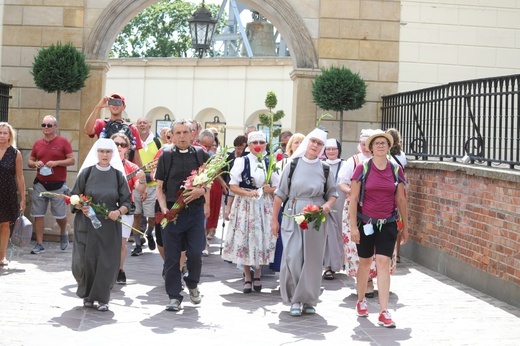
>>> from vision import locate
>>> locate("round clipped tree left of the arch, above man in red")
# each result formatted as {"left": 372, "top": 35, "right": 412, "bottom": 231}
{"left": 31, "top": 42, "right": 90, "bottom": 123}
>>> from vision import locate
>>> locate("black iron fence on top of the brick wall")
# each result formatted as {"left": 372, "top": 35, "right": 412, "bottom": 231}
{"left": 382, "top": 75, "right": 520, "bottom": 169}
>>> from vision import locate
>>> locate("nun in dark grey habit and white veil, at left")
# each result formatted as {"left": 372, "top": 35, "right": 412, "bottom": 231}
{"left": 72, "top": 138, "right": 131, "bottom": 311}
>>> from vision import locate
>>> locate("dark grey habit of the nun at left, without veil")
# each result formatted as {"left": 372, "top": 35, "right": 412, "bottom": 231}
{"left": 72, "top": 166, "right": 131, "bottom": 304}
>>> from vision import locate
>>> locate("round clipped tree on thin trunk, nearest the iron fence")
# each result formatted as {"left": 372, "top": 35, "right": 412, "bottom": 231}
{"left": 312, "top": 66, "right": 367, "bottom": 142}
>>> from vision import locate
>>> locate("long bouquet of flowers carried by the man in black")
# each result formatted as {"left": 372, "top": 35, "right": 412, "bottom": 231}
{"left": 155, "top": 147, "right": 229, "bottom": 228}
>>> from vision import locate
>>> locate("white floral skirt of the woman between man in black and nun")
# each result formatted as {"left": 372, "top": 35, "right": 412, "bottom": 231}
{"left": 222, "top": 195, "right": 276, "bottom": 268}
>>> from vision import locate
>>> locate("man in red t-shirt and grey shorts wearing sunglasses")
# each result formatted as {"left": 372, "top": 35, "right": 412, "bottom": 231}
{"left": 27, "top": 115, "right": 76, "bottom": 255}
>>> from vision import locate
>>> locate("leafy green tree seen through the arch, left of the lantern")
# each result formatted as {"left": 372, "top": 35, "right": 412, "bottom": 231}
{"left": 110, "top": 0, "right": 222, "bottom": 58}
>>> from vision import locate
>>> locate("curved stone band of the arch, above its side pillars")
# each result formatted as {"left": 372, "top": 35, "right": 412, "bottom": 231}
{"left": 85, "top": 0, "right": 318, "bottom": 68}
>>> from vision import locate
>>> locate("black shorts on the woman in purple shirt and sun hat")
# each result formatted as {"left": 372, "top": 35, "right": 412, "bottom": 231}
{"left": 356, "top": 221, "right": 397, "bottom": 258}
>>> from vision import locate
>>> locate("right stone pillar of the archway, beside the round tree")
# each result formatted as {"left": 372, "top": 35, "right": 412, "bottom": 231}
{"left": 291, "top": 68, "right": 321, "bottom": 134}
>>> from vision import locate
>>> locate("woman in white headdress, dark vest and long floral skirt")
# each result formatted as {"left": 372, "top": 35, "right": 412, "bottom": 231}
{"left": 222, "top": 131, "right": 278, "bottom": 293}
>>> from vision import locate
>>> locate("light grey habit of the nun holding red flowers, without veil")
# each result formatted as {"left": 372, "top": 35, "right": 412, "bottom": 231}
{"left": 275, "top": 157, "right": 338, "bottom": 306}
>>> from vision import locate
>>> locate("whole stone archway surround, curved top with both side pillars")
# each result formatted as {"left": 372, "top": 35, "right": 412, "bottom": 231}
{"left": 78, "top": 0, "right": 319, "bottom": 161}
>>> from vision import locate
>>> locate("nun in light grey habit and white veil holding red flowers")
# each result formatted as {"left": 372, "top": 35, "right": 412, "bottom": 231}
{"left": 271, "top": 129, "right": 338, "bottom": 316}
